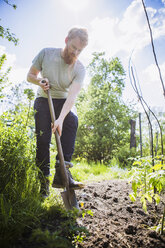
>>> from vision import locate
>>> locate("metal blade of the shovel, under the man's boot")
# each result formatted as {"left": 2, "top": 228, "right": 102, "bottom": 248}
{"left": 61, "top": 189, "right": 80, "bottom": 210}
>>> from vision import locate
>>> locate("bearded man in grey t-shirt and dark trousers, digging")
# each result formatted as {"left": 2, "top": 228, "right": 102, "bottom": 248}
{"left": 27, "top": 28, "right": 88, "bottom": 196}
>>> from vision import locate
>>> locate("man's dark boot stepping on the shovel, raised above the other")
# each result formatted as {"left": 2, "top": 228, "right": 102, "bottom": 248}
{"left": 52, "top": 163, "right": 85, "bottom": 189}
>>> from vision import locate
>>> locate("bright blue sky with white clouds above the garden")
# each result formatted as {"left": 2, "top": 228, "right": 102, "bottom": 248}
{"left": 0, "top": 0, "right": 165, "bottom": 111}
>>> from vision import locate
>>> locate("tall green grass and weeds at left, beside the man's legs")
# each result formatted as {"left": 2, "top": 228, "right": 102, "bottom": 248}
{"left": 0, "top": 107, "right": 40, "bottom": 245}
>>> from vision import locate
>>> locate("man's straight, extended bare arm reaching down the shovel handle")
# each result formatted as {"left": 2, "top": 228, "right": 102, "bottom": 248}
{"left": 52, "top": 82, "right": 81, "bottom": 136}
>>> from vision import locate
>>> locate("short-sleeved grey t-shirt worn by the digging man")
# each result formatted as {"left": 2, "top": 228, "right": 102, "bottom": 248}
{"left": 32, "top": 48, "right": 85, "bottom": 99}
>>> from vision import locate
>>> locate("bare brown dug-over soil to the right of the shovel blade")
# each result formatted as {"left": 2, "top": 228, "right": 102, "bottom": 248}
{"left": 76, "top": 180, "right": 165, "bottom": 248}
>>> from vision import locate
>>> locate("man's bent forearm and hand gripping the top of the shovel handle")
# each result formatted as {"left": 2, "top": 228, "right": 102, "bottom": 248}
{"left": 27, "top": 66, "right": 49, "bottom": 91}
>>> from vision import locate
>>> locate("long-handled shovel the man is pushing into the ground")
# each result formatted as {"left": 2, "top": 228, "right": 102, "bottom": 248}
{"left": 42, "top": 80, "right": 79, "bottom": 210}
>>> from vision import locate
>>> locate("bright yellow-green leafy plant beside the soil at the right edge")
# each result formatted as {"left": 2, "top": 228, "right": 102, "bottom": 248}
{"left": 130, "top": 157, "right": 165, "bottom": 232}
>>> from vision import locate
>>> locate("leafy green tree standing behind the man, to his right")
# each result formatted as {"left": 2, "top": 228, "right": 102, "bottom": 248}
{"left": 75, "top": 53, "right": 136, "bottom": 162}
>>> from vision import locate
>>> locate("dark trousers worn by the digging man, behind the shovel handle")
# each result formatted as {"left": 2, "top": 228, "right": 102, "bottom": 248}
{"left": 34, "top": 97, "right": 78, "bottom": 176}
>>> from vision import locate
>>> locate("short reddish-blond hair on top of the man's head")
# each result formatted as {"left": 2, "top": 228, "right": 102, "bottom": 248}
{"left": 67, "top": 27, "right": 88, "bottom": 46}
